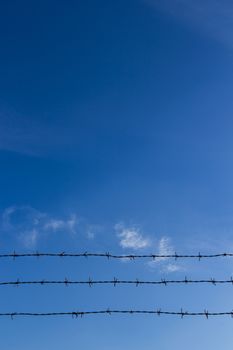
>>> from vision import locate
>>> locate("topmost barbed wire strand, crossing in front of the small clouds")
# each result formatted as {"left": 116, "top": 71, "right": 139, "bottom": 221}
{"left": 0, "top": 251, "right": 233, "bottom": 261}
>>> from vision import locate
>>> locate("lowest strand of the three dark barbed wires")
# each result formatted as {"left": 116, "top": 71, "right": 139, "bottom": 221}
{"left": 0, "top": 309, "right": 233, "bottom": 319}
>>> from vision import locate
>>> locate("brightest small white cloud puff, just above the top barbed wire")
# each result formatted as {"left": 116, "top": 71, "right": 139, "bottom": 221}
{"left": 115, "top": 224, "right": 150, "bottom": 250}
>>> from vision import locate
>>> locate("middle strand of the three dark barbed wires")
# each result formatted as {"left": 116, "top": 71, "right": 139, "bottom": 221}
{"left": 0, "top": 277, "right": 233, "bottom": 287}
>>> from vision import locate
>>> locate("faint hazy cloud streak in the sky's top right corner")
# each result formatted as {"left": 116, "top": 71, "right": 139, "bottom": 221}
{"left": 145, "top": 0, "right": 233, "bottom": 48}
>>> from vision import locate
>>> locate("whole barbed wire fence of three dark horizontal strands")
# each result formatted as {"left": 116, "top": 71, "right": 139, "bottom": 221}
{"left": 0, "top": 251, "right": 233, "bottom": 319}
